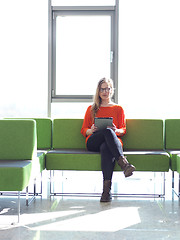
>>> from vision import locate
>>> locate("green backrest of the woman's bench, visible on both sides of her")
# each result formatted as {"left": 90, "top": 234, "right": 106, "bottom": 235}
{"left": 53, "top": 119, "right": 164, "bottom": 150}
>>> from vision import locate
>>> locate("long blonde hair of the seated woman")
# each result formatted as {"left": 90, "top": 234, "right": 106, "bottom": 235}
{"left": 91, "top": 77, "right": 114, "bottom": 119}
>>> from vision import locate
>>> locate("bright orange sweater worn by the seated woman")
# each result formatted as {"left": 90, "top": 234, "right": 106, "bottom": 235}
{"left": 81, "top": 105, "right": 126, "bottom": 144}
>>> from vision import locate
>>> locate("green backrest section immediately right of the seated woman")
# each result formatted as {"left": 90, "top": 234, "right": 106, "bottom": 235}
{"left": 122, "top": 119, "right": 164, "bottom": 150}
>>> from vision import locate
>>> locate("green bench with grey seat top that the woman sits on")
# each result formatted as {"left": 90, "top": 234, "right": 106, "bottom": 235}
{"left": 46, "top": 119, "right": 170, "bottom": 195}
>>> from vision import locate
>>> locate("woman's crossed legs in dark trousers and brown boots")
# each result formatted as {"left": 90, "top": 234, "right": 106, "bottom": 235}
{"left": 87, "top": 128, "right": 135, "bottom": 202}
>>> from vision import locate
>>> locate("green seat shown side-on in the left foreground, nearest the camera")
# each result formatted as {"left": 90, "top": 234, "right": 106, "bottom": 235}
{"left": 0, "top": 120, "right": 38, "bottom": 222}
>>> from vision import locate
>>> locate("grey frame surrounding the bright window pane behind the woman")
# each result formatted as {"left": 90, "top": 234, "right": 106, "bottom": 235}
{"left": 48, "top": 0, "right": 119, "bottom": 116}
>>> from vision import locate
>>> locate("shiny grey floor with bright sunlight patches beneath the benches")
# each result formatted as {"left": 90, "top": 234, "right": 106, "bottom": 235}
{"left": 0, "top": 173, "right": 180, "bottom": 240}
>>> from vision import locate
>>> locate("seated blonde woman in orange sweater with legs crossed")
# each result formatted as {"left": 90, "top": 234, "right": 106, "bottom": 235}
{"left": 81, "top": 78, "right": 135, "bottom": 202}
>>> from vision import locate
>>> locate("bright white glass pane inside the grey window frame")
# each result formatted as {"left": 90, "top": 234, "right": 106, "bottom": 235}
{"left": 53, "top": 15, "right": 111, "bottom": 99}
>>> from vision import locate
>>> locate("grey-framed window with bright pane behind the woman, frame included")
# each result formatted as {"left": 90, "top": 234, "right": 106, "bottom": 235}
{"left": 48, "top": 0, "right": 118, "bottom": 115}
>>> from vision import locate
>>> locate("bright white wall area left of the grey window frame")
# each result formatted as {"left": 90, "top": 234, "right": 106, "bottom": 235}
{"left": 0, "top": 0, "right": 48, "bottom": 117}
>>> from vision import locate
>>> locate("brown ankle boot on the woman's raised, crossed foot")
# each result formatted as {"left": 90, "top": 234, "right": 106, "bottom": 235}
{"left": 117, "top": 156, "right": 136, "bottom": 177}
